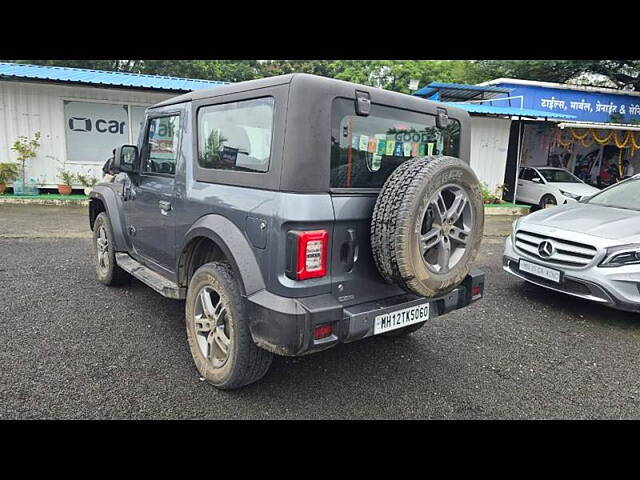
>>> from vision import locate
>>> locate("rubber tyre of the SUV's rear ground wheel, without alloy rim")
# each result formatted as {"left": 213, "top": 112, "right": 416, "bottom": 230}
{"left": 185, "top": 262, "right": 273, "bottom": 390}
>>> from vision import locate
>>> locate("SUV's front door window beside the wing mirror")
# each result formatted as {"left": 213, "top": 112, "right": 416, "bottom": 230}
{"left": 142, "top": 115, "right": 180, "bottom": 175}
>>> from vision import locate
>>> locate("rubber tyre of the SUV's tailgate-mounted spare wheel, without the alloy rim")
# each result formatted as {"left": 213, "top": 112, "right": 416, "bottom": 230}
{"left": 371, "top": 156, "right": 484, "bottom": 297}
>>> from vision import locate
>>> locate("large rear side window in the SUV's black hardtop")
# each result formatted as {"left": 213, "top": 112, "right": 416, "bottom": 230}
{"left": 198, "top": 97, "right": 275, "bottom": 172}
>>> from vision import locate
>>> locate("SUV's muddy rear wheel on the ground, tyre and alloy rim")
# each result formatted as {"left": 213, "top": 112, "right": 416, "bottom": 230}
{"left": 185, "top": 262, "right": 273, "bottom": 390}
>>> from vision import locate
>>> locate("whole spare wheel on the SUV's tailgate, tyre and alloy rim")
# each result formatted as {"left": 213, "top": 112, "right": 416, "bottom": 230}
{"left": 371, "top": 156, "right": 484, "bottom": 297}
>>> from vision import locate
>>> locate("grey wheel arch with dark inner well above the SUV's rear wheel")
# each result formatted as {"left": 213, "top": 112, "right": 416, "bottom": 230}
{"left": 176, "top": 214, "right": 265, "bottom": 296}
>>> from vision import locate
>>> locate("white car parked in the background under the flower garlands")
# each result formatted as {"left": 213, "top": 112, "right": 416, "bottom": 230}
{"left": 516, "top": 167, "right": 600, "bottom": 208}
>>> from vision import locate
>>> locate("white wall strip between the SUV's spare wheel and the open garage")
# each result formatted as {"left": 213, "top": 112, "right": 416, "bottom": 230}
{"left": 471, "top": 116, "right": 511, "bottom": 192}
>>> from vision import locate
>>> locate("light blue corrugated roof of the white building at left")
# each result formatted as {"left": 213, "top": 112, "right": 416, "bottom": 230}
{"left": 0, "top": 63, "right": 228, "bottom": 92}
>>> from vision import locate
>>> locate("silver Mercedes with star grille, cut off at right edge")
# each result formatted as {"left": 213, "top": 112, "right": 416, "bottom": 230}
{"left": 503, "top": 175, "right": 640, "bottom": 312}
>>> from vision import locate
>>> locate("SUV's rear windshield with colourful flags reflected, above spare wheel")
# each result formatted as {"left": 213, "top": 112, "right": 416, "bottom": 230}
{"left": 331, "top": 98, "right": 460, "bottom": 188}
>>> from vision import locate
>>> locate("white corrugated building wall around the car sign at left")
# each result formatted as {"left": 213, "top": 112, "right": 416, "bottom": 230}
{"left": 0, "top": 81, "right": 178, "bottom": 188}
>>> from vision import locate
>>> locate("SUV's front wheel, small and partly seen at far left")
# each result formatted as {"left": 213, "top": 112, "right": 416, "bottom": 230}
{"left": 93, "top": 212, "right": 131, "bottom": 286}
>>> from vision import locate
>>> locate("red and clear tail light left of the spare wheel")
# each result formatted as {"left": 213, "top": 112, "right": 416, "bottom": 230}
{"left": 286, "top": 230, "right": 329, "bottom": 280}
